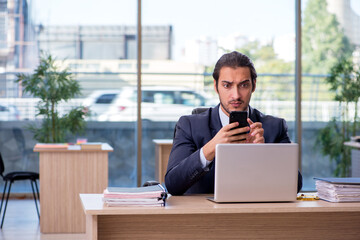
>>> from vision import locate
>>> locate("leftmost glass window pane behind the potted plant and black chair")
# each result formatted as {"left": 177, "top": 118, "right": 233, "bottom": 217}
{"left": 0, "top": 0, "right": 137, "bottom": 192}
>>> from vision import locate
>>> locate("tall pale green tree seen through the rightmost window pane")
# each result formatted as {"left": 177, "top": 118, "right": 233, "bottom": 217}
{"left": 302, "top": 0, "right": 354, "bottom": 104}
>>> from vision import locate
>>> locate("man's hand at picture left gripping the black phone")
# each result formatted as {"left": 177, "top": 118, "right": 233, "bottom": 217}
{"left": 203, "top": 122, "right": 250, "bottom": 161}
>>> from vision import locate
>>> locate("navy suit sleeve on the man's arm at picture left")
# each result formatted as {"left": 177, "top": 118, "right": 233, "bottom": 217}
{"left": 165, "top": 117, "right": 212, "bottom": 195}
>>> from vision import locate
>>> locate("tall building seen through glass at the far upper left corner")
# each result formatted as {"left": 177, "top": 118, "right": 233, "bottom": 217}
{"left": 0, "top": 0, "right": 35, "bottom": 97}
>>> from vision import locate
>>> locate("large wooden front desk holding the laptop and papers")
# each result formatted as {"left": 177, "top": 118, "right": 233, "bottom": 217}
{"left": 80, "top": 194, "right": 360, "bottom": 240}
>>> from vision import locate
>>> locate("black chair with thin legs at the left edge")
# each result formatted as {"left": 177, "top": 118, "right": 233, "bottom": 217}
{"left": 0, "top": 153, "right": 40, "bottom": 228}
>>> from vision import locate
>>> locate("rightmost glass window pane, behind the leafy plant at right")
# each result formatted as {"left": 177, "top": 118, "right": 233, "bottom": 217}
{"left": 302, "top": 0, "right": 360, "bottom": 190}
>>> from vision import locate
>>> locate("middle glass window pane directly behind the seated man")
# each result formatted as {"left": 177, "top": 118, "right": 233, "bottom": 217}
{"left": 142, "top": 0, "right": 295, "bottom": 184}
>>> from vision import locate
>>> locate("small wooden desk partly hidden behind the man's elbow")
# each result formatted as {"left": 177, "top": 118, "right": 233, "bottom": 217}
{"left": 153, "top": 139, "right": 172, "bottom": 183}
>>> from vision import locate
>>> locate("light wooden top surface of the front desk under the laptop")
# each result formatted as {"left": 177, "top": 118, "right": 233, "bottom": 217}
{"left": 80, "top": 194, "right": 360, "bottom": 215}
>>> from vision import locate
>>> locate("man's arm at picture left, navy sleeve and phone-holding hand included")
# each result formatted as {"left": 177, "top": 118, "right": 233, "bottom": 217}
{"left": 165, "top": 117, "right": 249, "bottom": 195}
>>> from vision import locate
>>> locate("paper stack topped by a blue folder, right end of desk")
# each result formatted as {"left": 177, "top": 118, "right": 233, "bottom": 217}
{"left": 314, "top": 178, "right": 360, "bottom": 202}
